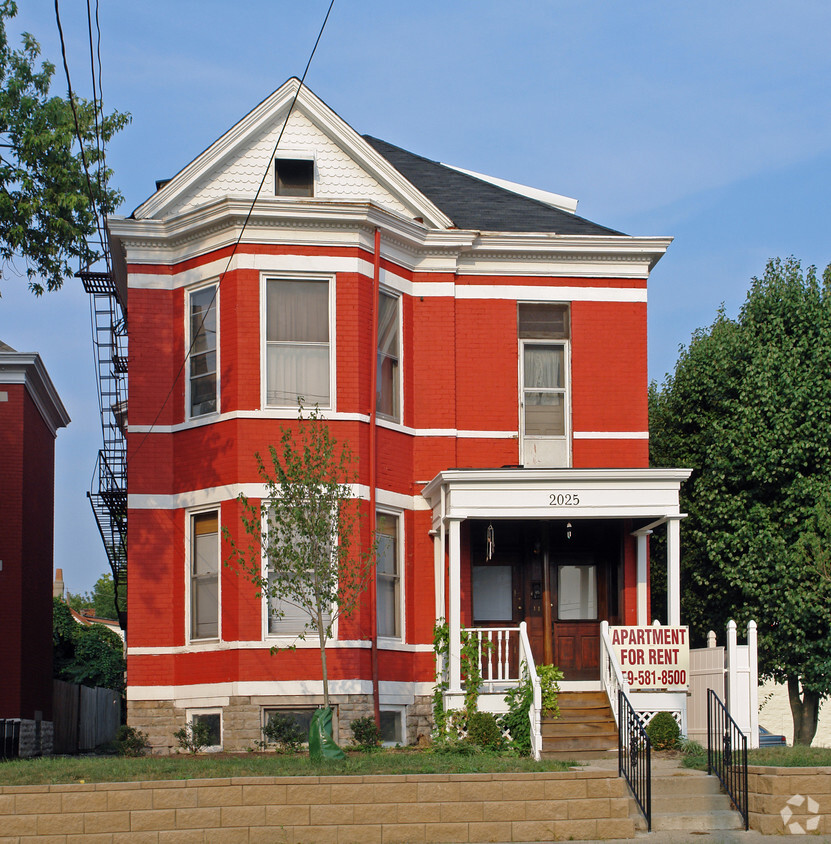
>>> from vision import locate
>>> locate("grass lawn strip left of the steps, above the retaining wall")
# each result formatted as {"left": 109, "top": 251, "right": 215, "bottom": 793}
{"left": 0, "top": 750, "right": 569, "bottom": 785}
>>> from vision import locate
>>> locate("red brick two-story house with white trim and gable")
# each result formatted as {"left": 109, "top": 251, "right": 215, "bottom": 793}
{"left": 109, "top": 80, "right": 688, "bottom": 749}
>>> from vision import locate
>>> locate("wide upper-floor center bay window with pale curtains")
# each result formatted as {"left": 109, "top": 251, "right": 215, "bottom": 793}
{"left": 265, "top": 278, "right": 332, "bottom": 407}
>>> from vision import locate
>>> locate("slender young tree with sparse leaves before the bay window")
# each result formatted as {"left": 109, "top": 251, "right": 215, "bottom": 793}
{"left": 223, "top": 406, "right": 374, "bottom": 709}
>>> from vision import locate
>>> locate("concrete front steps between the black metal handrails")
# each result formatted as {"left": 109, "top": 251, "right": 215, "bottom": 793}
{"left": 630, "top": 757, "right": 744, "bottom": 833}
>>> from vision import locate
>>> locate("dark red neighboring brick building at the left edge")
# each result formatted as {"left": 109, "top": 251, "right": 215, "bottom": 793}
{"left": 0, "top": 342, "right": 69, "bottom": 756}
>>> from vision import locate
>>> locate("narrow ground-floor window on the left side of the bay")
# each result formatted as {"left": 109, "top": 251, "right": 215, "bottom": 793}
{"left": 189, "top": 510, "right": 219, "bottom": 639}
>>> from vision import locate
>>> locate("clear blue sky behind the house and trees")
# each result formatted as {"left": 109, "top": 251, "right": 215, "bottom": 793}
{"left": 0, "top": 0, "right": 831, "bottom": 592}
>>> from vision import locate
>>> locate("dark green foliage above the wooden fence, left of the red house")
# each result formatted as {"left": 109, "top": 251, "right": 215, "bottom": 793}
{"left": 52, "top": 598, "right": 125, "bottom": 692}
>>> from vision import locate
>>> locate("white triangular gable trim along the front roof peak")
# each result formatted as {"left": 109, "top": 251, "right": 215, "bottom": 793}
{"left": 134, "top": 79, "right": 453, "bottom": 229}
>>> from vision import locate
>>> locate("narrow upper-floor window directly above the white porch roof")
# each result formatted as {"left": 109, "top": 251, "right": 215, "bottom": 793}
{"left": 518, "top": 302, "right": 570, "bottom": 466}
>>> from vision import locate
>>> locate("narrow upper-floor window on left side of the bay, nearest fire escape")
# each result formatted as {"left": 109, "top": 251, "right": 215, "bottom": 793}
{"left": 187, "top": 284, "right": 218, "bottom": 417}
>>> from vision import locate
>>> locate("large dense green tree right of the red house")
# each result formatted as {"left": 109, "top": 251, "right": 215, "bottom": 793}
{"left": 650, "top": 258, "right": 831, "bottom": 744}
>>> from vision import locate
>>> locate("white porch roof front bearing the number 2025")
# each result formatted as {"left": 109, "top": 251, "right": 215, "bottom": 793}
{"left": 422, "top": 468, "right": 692, "bottom": 527}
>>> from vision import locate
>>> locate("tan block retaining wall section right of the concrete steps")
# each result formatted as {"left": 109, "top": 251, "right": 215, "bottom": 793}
{"left": 747, "top": 765, "right": 831, "bottom": 835}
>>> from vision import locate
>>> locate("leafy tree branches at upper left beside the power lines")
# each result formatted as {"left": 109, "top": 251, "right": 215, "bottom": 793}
{"left": 0, "top": 0, "right": 130, "bottom": 295}
